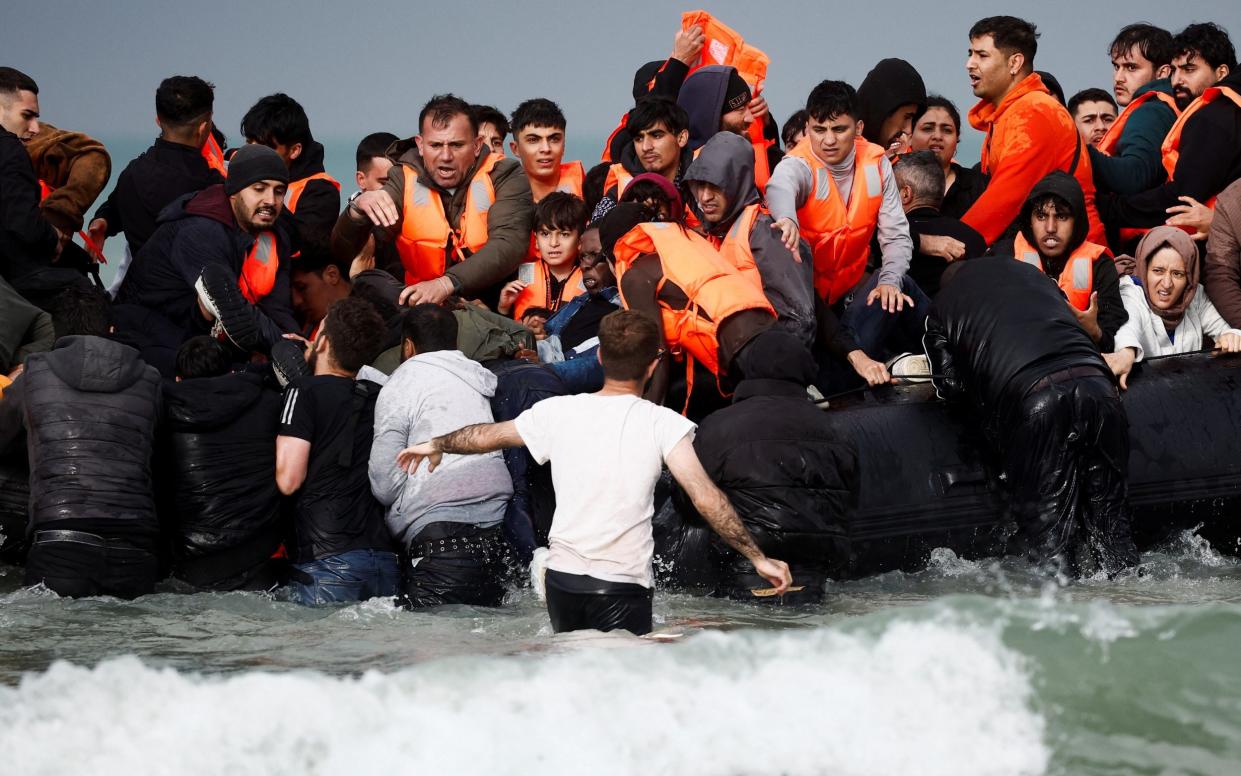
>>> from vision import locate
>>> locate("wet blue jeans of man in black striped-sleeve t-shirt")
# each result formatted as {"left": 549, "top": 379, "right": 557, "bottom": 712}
{"left": 289, "top": 550, "right": 401, "bottom": 606}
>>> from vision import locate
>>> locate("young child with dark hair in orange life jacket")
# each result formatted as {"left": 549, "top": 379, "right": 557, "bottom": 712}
{"left": 496, "top": 191, "right": 587, "bottom": 320}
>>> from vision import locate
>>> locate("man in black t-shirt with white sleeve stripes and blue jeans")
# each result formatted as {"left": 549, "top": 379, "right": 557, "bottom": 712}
{"left": 276, "top": 298, "right": 401, "bottom": 605}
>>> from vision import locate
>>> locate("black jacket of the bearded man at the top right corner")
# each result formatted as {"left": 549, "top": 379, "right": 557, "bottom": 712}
{"left": 1100, "top": 68, "right": 1241, "bottom": 228}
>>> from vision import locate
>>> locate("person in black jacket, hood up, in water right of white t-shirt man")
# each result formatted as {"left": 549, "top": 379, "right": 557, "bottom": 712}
{"left": 694, "top": 329, "right": 858, "bottom": 603}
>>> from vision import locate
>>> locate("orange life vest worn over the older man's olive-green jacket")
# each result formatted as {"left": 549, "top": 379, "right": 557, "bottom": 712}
{"left": 396, "top": 154, "right": 504, "bottom": 284}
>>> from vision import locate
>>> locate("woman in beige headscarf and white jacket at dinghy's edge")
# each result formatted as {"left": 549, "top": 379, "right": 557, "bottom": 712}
{"left": 1107, "top": 226, "right": 1241, "bottom": 387}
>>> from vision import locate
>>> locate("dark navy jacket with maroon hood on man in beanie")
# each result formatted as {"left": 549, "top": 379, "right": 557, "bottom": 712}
{"left": 117, "top": 185, "right": 298, "bottom": 360}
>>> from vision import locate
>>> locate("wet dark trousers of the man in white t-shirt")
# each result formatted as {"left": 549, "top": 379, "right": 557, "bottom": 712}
{"left": 546, "top": 569, "right": 652, "bottom": 636}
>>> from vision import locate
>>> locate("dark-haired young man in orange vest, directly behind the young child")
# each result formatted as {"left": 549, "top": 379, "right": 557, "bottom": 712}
{"left": 509, "top": 97, "right": 586, "bottom": 204}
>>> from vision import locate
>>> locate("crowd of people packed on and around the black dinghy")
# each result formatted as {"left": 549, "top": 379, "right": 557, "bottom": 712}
{"left": 0, "top": 12, "right": 1241, "bottom": 633}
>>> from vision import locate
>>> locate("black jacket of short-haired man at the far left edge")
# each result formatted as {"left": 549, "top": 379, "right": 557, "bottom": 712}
{"left": 0, "top": 127, "right": 58, "bottom": 291}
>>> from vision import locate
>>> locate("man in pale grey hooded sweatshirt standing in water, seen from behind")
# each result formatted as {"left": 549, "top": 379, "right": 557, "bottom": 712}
{"left": 369, "top": 304, "right": 513, "bottom": 608}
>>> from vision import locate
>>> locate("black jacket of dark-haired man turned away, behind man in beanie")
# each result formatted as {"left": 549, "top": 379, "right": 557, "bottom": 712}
{"left": 94, "top": 138, "right": 223, "bottom": 256}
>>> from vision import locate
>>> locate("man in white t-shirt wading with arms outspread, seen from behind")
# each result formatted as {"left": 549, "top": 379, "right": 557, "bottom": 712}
{"left": 397, "top": 305, "right": 792, "bottom": 636}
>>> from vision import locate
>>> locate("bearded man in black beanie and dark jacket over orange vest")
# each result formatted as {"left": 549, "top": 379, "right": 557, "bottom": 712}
{"left": 115, "top": 145, "right": 297, "bottom": 376}
